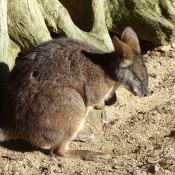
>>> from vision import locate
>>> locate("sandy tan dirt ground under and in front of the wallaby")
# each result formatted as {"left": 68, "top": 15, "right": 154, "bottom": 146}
{"left": 0, "top": 45, "right": 175, "bottom": 175}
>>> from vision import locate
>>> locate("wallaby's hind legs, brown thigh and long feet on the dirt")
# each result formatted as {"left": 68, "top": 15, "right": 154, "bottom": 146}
{"left": 49, "top": 87, "right": 110, "bottom": 160}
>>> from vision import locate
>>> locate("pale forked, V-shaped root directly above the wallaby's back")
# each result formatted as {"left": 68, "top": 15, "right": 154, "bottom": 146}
{"left": 38, "top": 0, "right": 113, "bottom": 51}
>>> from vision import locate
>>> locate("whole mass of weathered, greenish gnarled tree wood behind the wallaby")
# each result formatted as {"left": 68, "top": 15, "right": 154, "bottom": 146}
{"left": 0, "top": 0, "right": 175, "bottom": 128}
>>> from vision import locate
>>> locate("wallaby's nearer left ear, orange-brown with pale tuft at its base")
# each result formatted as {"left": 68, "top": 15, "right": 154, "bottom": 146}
{"left": 113, "top": 36, "right": 133, "bottom": 67}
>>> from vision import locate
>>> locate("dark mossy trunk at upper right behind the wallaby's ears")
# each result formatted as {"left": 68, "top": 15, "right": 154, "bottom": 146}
{"left": 106, "top": 0, "right": 175, "bottom": 45}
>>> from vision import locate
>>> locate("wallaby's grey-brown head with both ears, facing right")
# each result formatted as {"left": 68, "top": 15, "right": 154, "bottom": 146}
{"left": 113, "top": 27, "right": 149, "bottom": 97}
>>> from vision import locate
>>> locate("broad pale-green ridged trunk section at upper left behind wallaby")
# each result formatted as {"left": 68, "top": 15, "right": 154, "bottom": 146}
{"left": 8, "top": 0, "right": 51, "bottom": 52}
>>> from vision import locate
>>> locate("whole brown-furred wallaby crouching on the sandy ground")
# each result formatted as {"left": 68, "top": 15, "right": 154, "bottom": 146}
{"left": 0, "top": 27, "right": 148, "bottom": 160}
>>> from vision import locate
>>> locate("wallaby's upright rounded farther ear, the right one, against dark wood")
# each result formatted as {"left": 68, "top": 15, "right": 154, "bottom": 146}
{"left": 121, "top": 27, "right": 141, "bottom": 53}
